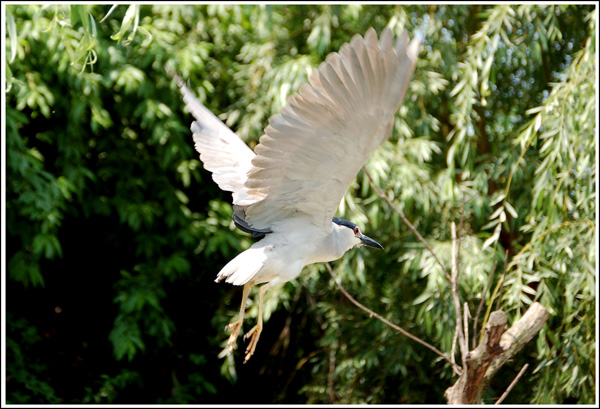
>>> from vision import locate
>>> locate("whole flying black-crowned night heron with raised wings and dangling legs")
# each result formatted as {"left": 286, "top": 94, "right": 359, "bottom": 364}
{"left": 171, "top": 28, "right": 418, "bottom": 362}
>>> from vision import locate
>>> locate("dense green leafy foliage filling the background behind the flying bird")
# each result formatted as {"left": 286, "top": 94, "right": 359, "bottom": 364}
{"left": 5, "top": 4, "right": 597, "bottom": 404}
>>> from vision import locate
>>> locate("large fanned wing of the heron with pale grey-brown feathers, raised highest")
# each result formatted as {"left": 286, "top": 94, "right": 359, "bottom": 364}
{"left": 243, "top": 28, "right": 418, "bottom": 229}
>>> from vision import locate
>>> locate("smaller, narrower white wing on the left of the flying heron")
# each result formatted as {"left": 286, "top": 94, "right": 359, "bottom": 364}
{"left": 167, "top": 68, "right": 262, "bottom": 205}
